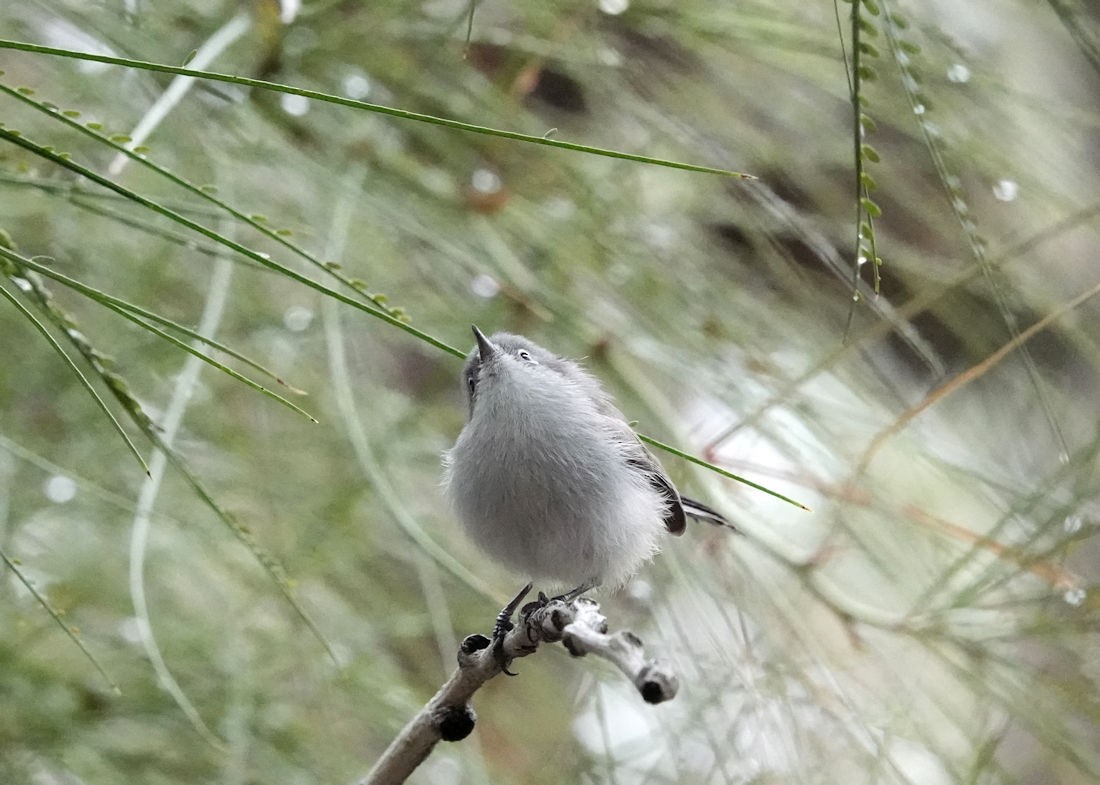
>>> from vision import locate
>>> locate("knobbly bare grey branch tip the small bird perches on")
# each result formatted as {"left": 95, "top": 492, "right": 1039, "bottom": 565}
{"left": 359, "top": 596, "right": 680, "bottom": 785}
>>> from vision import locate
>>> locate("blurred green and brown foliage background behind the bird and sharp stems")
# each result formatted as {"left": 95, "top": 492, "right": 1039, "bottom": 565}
{"left": 0, "top": 0, "right": 1100, "bottom": 785}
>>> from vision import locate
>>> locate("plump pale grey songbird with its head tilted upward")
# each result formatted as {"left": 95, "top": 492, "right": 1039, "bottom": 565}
{"left": 443, "top": 327, "right": 734, "bottom": 596}
